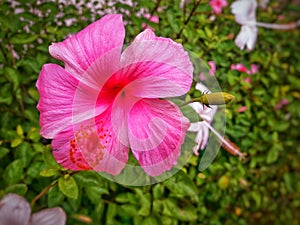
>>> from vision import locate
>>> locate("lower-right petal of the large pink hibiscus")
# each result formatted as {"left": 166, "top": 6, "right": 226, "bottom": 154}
{"left": 128, "top": 99, "right": 189, "bottom": 176}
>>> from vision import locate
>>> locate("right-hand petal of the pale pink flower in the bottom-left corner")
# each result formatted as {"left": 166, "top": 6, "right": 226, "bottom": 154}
{"left": 30, "top": 207, "right": 66, "bottom": 225}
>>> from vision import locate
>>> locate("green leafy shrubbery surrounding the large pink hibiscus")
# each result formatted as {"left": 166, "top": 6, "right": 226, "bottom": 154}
{"left": 0, "top": 0, "right": 300, "bottom": 225}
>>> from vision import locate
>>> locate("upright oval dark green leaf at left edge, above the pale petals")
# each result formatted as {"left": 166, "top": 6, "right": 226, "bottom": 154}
{"left": 3, "top": 159, "right": 24, "bottom": 185}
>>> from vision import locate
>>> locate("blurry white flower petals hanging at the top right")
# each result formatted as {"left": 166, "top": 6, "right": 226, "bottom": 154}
{"left": 231, "top": 0, "right": 258, "bottom": 51}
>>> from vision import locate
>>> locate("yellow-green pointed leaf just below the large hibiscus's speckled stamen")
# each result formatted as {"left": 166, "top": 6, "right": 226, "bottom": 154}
{"left": 58, "top": 176, "right": 78, "bottom": 199}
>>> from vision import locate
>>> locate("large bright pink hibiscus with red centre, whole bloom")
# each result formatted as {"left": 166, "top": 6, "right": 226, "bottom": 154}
{"left": 37, "top": 15, "right": 193, "bottom": 176}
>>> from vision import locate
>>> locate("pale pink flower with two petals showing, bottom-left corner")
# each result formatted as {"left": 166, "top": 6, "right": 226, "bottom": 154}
{"left": 0, "top": 194, "right": 66, "bottom": 225}
